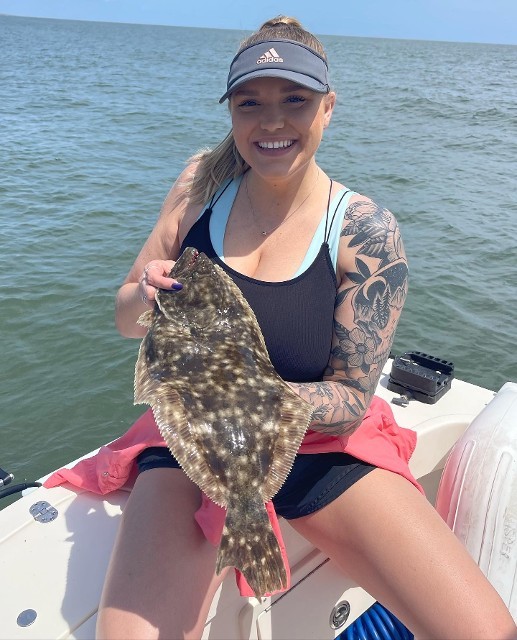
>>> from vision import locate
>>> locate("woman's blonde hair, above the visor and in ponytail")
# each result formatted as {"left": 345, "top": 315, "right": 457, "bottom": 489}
{"left": 185, "top": 16, "right": 327, "bottom": 204}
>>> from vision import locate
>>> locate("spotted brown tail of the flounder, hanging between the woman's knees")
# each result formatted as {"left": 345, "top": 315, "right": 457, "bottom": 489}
{"left": 216, "top": 495, "right": 287, "bottom": 598}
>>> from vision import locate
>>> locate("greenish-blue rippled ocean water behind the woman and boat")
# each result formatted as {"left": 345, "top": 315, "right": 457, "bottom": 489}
{"left": 0, "top": 16, "right": 517, "bottom": 492}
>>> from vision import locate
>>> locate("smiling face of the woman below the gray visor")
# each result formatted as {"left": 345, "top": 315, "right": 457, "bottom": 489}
{"left": 230, "top": 78, "right": 335, "bottom": 180}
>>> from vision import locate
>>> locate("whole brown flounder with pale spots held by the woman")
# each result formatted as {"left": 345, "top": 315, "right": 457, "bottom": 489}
{"left": 135, "top": 247, "right": 312, "bottom": 597}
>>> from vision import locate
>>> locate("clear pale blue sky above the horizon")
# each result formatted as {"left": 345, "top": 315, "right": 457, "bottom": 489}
{"left": 0, "top": 0, "right": 517, "bottom": 44}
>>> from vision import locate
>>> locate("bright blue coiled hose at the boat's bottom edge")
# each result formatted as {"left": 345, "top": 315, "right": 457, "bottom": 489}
{"left": 336, "top": 602, "right": 415, "bottom": 640}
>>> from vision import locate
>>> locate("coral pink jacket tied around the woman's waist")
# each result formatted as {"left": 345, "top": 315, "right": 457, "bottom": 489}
{"left": 44, "top": 396, "right": 423, "bottom": 596}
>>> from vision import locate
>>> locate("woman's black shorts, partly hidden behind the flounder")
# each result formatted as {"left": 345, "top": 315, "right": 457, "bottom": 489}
{"left": 137, "top": 447, "right": 375, "bottom": 520}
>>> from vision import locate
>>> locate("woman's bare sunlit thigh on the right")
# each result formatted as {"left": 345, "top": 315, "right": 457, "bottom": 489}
{"left": 289, "top": 469, "right": 517, "bottom": 640}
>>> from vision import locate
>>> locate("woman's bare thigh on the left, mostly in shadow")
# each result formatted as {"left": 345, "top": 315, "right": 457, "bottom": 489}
{"left": 97, "top": 469, "right": 228, "bottom": 639}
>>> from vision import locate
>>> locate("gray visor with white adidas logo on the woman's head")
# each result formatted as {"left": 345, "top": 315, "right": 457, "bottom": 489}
{"left": 219, "top": 40, "right": 330, "bottom": 102}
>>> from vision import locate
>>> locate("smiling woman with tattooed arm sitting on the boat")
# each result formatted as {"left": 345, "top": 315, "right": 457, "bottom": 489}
{"left": 97, "top": 17, "right": 517, "bottom": 640}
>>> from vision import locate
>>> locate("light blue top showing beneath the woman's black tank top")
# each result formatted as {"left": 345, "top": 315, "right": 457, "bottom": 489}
{"left": 203, "top": 176, "right": 354, "bottom": 278}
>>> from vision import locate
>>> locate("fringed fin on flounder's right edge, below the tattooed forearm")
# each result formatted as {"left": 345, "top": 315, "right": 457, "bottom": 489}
{"left": 262, "top": 385, "right": 313, "bottom": 502}
